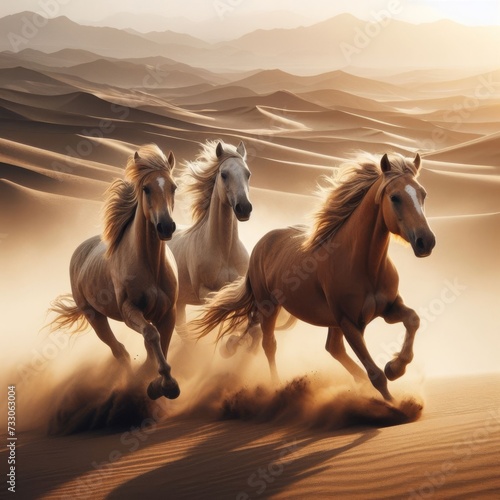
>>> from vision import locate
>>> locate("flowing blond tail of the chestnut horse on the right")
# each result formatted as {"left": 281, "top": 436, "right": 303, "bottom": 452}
{"left": 190, "top": 276, "right": 255, "bottom": 342}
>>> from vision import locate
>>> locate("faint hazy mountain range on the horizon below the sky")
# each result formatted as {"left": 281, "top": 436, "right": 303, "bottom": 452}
{"left": 0, "top": 12, "right": 500, "bottom": 75}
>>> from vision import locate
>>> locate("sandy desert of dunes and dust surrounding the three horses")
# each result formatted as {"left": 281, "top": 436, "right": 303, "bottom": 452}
{"left": 0, "top": 13, "right": 500, "bottom": 500}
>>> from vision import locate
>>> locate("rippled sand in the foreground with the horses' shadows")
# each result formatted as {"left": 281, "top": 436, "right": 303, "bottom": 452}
{"left": 0, "top": 375, "right": 500, "bottom": 499}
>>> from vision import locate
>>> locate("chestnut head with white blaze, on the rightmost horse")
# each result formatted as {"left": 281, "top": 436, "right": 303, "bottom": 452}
{"left": 380, "top": 154, "right": 436, "bottom": 257}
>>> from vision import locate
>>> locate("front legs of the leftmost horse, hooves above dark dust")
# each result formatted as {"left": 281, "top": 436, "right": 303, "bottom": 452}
{"left": 122, "top": 300, "right": 180, "bottom": 399}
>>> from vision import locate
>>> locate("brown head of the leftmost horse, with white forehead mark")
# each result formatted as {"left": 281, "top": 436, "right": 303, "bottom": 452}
{"left": 134, "top": 152, "right": 177, "bottom": 241}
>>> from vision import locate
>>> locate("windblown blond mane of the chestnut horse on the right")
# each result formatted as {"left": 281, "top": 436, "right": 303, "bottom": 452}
{"left": 303, "top": 153, "right": 417, "bottom": 250}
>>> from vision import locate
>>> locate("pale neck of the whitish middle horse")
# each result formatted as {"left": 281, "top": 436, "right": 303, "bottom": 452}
{"left": 205, "top": 182, "right": 238, "bottom": 258}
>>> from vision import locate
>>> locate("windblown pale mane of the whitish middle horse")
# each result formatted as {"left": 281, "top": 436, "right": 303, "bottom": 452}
{"left": 180, "top": 141, "right": 245, "bottom": 229}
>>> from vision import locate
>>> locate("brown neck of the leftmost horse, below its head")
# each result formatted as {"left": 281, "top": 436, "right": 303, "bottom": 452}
{"left": 130, "top": 201, "right": 165, "bottom": 273}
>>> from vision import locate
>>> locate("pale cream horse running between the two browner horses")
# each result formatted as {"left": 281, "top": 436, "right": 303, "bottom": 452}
{"left": 168, "top": 141, "right": 252, "bottom": 333}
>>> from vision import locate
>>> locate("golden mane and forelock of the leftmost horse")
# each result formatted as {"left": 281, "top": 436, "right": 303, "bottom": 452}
{"left": 102, "top": 144, "right": 171, "bottom": 256}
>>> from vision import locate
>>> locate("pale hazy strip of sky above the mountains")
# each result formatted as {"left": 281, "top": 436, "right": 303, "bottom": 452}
{"left": 0, "top": 0, "right": 500, "bottom": 25}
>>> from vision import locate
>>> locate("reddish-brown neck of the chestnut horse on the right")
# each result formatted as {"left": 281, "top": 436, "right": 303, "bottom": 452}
{"left": 343, "top": 178, "right": 390, "bottom": 278}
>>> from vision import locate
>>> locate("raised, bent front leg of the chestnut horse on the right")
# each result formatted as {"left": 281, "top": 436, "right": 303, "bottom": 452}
{"left": 382, "top": 295, "right": 420, "bottom": 380}
